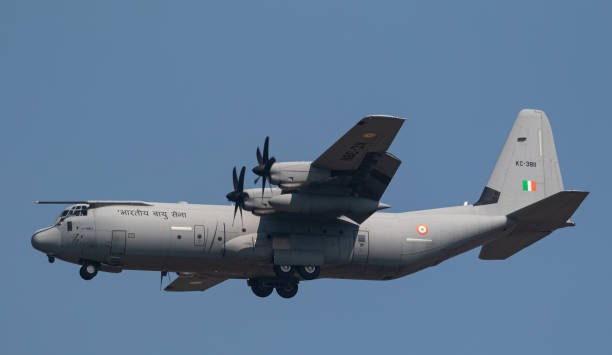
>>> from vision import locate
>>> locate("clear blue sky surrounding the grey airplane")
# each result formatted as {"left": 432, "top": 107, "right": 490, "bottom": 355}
{"left": 0, "top": 0, "right": 612, "bottom": 355}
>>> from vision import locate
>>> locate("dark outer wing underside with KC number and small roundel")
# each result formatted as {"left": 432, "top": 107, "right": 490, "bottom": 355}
{"left": 312, "top": 116, "right": 404, "bottom": 171}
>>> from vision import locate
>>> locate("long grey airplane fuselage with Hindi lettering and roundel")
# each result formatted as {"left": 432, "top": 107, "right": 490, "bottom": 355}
{"left": 34, "top": 203, "right": 509, "bottom": 280}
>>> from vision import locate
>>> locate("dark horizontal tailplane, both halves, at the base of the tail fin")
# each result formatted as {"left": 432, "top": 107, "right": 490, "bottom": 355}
{"left": 478, "top": 191, "right": 589, "bottom": 260}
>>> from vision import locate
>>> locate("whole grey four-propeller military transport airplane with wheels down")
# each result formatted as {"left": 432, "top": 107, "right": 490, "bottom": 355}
{"left": 32, "top": 110, "right": 588, "bottom": 298}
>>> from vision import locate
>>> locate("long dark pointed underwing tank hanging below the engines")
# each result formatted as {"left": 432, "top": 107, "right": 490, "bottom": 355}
{"left": 268, "top": 193, "right": 389, "bottom": 216}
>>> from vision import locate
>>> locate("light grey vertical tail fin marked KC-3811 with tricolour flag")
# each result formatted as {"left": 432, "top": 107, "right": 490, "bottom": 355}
{"left": 475, "top": 109, "right": 564, "bottom": 214}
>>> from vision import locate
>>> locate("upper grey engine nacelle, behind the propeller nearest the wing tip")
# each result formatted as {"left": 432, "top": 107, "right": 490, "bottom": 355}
{"left": 270, "top": 161, "right": 331, "bottom": 190}
